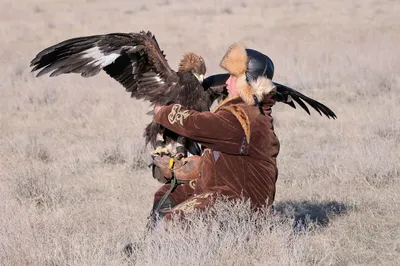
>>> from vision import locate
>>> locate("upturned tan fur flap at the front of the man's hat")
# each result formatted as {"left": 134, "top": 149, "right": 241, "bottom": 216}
{"left": 220, "top": 43, "right": 248, "bottom": 77}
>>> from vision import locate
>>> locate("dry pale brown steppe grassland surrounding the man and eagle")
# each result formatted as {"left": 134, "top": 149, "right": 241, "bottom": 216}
{"left": 0, "top": 0, "right": 400, "bottom": 265}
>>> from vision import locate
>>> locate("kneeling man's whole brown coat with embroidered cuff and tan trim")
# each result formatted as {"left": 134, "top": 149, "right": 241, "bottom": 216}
{"left": 155, "top": 95, "right": 280, "bottom": 217}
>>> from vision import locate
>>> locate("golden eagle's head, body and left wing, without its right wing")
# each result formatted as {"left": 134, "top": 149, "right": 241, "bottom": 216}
{"left": 30, "top": 31, "right": 225, "bottom": 158}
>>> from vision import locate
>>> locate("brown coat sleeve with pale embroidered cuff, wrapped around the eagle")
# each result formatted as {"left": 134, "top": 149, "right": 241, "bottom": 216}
{"left": 155, "top": 104, "right": 245, "bottom": 154}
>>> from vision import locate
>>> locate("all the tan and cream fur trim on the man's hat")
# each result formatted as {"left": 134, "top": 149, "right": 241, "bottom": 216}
{"left": 220, "top": 43, "right": 275, "bottom": 105}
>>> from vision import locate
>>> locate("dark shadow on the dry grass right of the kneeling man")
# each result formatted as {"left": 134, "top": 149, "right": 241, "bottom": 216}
{"left": 274, "top": 201, "right": 349, "bottom": 231}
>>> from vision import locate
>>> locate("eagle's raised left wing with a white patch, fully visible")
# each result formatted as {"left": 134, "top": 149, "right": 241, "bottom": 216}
{"left": 31, "top": 31, "right": 179, "bottom": 103}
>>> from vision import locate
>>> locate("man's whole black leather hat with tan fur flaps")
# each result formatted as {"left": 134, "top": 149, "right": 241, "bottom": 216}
{"left": 220, "top": 43, "right": 275, "bottom": 105}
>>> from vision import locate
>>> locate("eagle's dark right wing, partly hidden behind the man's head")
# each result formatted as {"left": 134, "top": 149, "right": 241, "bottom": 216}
{"left": 203, "top": 73, "right": 337, "bottom": 119}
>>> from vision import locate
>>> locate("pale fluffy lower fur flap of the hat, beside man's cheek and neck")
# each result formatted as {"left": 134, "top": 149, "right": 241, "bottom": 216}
{"left": 236, "top": 75, "right": 276, "bottom": 106}
